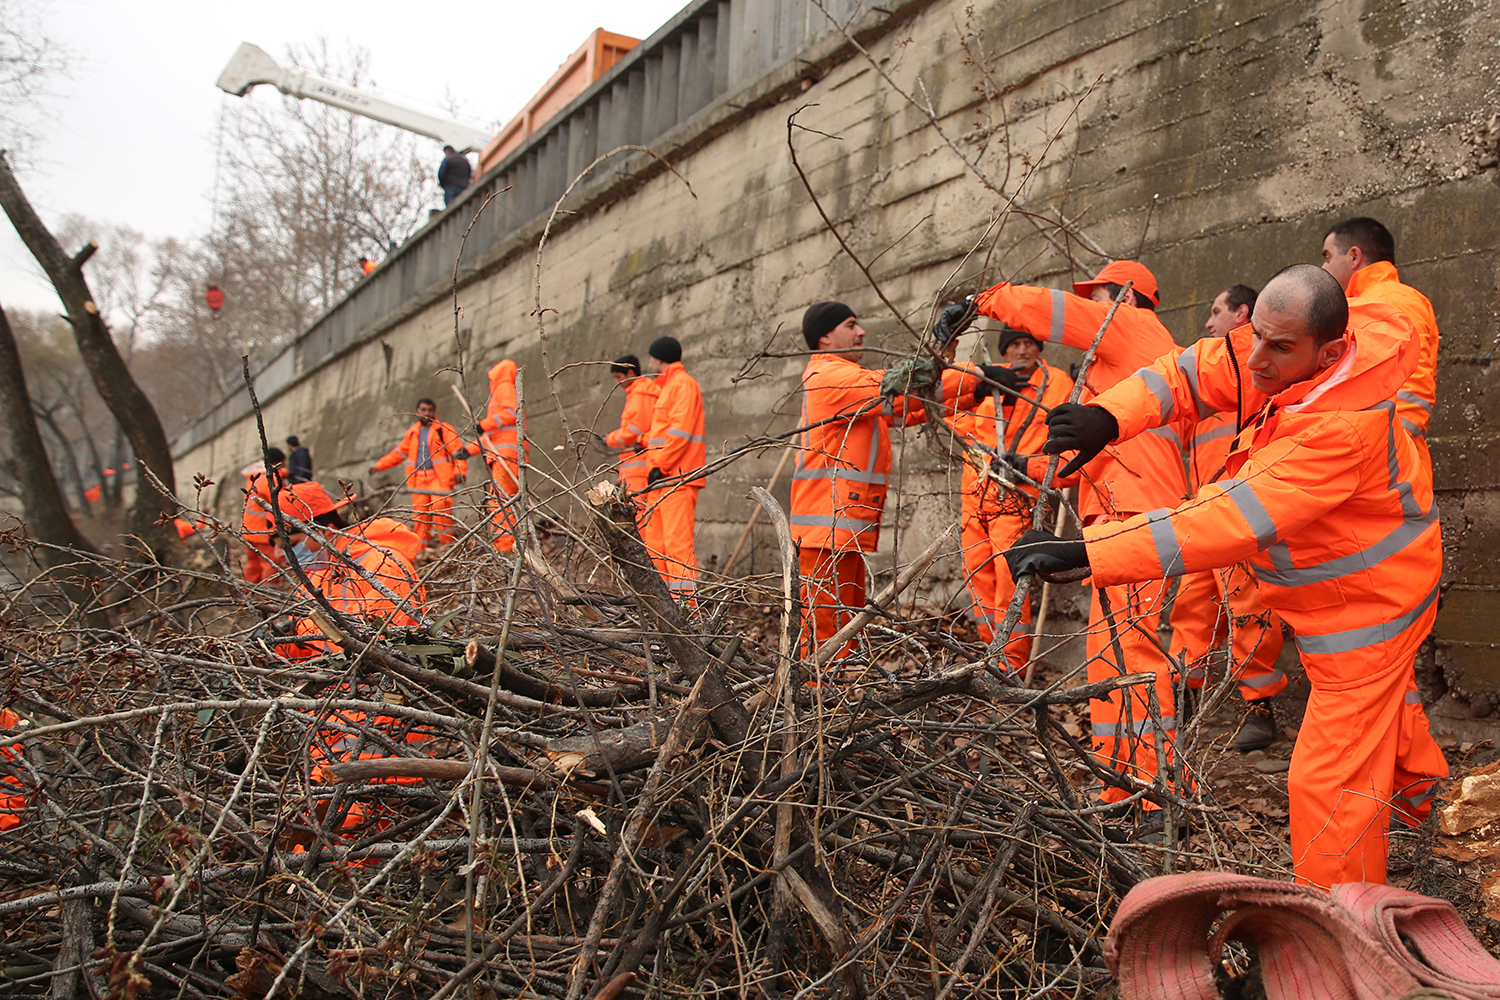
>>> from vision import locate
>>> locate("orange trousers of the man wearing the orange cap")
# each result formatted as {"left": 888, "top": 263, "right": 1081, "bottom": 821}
{"left": 1085, "top": 580, "right": 1178, "bottom": 810}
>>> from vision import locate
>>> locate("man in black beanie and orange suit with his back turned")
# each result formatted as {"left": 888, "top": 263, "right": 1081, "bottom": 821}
{"left": 645, "top": 337, "right": 708, "bottom": 598}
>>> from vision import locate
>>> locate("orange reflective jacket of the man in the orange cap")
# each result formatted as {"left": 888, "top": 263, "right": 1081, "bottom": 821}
{"left": 975, "top": 282, "right": 1188, "bottom": 519}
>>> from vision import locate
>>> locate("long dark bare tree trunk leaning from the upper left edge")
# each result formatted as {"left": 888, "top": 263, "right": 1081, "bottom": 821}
{"left": 0, "top": 153, "right": 177, "bottom": 549}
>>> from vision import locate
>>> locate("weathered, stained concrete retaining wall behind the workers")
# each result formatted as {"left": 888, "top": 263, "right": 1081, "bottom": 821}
{"left": 177, "top": 0, "right": 1500, "bottom": 696}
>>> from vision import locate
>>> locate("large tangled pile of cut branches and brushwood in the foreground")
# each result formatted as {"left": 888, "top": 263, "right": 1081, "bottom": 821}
{"left": 0, "top": 490, "right": 1233, "bottom": 1000}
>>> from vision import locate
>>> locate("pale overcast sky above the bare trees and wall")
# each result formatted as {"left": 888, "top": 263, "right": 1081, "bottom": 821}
{"left": 0, "top": 0, "right": 687, "bottom": 309}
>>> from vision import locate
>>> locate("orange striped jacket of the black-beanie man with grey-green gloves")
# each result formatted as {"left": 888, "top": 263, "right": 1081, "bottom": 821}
{"left": 791, "top": 354, "right": 978, "bottom": 552}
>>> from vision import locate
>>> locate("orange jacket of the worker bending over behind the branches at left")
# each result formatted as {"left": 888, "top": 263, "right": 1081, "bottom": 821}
{"left": 284, "top": 517, "right": 428, "bottom": 660}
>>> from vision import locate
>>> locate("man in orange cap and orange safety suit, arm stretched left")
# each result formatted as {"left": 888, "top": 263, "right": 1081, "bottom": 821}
{"left": 948, "top": 261, "right": 1188, "bottom": 811}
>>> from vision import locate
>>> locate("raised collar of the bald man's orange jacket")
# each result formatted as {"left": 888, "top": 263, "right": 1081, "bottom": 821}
{"left": 1230, "top": 298, "right": 1422, "bottom": 412}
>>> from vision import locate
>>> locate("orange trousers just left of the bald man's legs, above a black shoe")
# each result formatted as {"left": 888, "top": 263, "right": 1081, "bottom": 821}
{"left": 1169, "top": 564, "right": 1287, "bottom": 702}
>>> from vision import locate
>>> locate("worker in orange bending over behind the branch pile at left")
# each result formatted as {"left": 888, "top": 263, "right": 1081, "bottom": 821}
{"left": 276, "top": 483, "right": 426, "bottom": 660}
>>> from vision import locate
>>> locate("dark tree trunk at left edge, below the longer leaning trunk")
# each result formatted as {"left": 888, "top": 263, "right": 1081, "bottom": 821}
{"left": 0, "top": 307, "right": 95, "bottom": 565}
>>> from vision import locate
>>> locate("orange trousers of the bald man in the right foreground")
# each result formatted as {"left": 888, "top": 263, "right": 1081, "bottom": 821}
{"left": 1287, "top": 601, "right": 1448, "bottom": 889}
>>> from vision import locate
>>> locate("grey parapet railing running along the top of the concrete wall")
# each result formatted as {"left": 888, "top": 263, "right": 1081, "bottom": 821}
{"left": 173, "top": 0, "right": 870, "bottom": 454}
